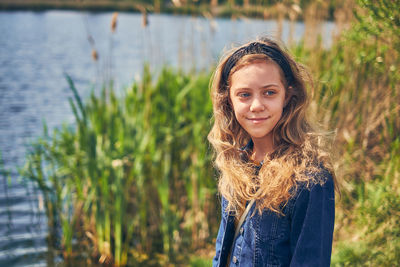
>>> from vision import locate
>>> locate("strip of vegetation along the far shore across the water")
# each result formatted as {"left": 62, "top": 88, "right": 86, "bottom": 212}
{"left": 0, "top": 0, "right": 343, "bottom": 21}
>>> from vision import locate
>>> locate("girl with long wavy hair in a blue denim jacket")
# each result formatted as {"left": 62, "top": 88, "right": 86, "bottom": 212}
{"left": 208, "top": 38, "right": 335, "bottom": 267}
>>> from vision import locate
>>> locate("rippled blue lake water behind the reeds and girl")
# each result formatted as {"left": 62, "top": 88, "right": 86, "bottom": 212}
{"left": 0, "top": 11, "right": 334, "bottom": 266}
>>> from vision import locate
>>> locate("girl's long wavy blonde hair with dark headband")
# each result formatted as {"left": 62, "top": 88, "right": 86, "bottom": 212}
{"left": 208, "top": 38, "right": 334, "bottom": 217}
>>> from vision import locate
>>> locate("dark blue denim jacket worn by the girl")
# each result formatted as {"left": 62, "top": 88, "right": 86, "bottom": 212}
{"left": 213, "top": 169, "right": 335, "bottom": 267}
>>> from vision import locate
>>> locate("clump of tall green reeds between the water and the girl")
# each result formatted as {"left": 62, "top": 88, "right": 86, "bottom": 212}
{"left": 24, "top": 68, "right": 217, "bottom": 266}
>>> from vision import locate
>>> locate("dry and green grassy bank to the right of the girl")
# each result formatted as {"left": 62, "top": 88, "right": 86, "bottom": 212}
{"left": 290, "top": 0, "right": 400, "bottom": 266}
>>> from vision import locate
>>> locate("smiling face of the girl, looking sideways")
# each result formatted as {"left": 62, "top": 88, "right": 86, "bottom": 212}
{"left": 229, "top": 61, "right": 286, "bottom": 147}
